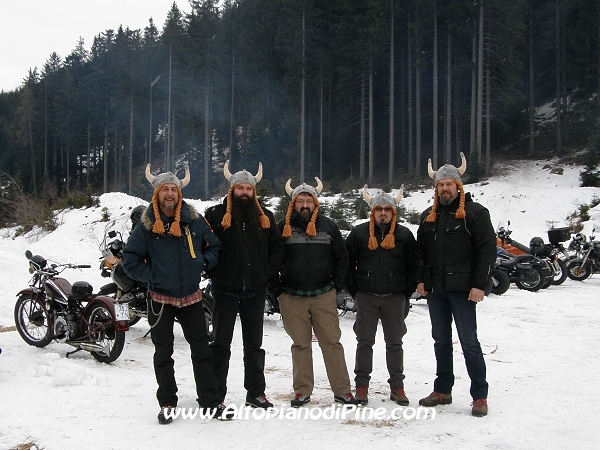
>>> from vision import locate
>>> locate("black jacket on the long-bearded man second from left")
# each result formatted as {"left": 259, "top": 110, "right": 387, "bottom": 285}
{"left": 204, "top": 198, "right": 285, "bottom": 291}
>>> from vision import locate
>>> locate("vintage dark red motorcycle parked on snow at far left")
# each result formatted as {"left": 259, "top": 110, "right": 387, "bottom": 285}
{"left": 14, "top": 250, "right": 129, "bottom": 364}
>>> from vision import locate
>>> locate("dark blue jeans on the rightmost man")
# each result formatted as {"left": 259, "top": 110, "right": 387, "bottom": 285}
{"left": 427, "top": 292, "right": 488, "bottom": 399}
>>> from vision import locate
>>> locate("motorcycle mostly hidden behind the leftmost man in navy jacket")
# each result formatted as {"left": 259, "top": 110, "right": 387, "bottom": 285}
{"left": 100, "top": 230, "right": 215, "bottom": 342}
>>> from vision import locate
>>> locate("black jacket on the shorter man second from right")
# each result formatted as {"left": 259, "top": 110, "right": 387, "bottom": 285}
{"left": 346, "top": 222, "right": 417, "bottom": 298}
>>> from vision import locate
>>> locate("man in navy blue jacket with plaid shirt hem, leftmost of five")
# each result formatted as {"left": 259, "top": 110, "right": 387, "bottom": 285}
{"left": 122, "top": 164, "right": 230, "bottom": 424}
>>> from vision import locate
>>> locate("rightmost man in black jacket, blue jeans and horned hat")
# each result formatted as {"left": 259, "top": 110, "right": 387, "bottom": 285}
{"left": 416, "top": 153, "right": 496, "bottom": 416}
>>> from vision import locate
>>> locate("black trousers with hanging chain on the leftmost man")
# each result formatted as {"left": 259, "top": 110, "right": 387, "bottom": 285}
{"left": 148, "top": 301, "right": 221, "bottom": 408}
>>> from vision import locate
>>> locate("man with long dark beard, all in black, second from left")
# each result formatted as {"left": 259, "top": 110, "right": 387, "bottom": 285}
{"left": 205, "top": 161, "right": 285, "bottom": 408}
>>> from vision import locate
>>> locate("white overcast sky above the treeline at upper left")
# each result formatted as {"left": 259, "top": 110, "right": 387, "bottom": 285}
{"left": 0, "top": 0, "right": 191, "bottom": 92}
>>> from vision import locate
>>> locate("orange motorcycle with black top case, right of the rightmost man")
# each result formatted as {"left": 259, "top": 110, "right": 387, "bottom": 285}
{"left": 496, "top": 225, "right": 567, "bottom": 289}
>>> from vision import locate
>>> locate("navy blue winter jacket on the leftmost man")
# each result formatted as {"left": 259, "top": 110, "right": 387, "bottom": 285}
{"left": 122, "top": 202, "right": 221, "bottom": 298}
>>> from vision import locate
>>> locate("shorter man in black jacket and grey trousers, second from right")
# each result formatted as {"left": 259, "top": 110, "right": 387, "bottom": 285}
{"left": 346, "top": 185, "right": 416, "bottom": 406}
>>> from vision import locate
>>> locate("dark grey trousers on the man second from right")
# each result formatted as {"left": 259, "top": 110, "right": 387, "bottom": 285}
{"left": 354, "top": 291, "right": 406, "bottom": 389}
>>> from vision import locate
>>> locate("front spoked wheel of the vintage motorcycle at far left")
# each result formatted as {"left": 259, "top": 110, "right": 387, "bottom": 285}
{"left": 15, "top": 294, "right": 52, "bottom": 347}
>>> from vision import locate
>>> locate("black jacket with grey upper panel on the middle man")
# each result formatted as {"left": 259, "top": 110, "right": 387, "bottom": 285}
{"left": 271, "top": 212, "right": 348, "bottom": 296}
